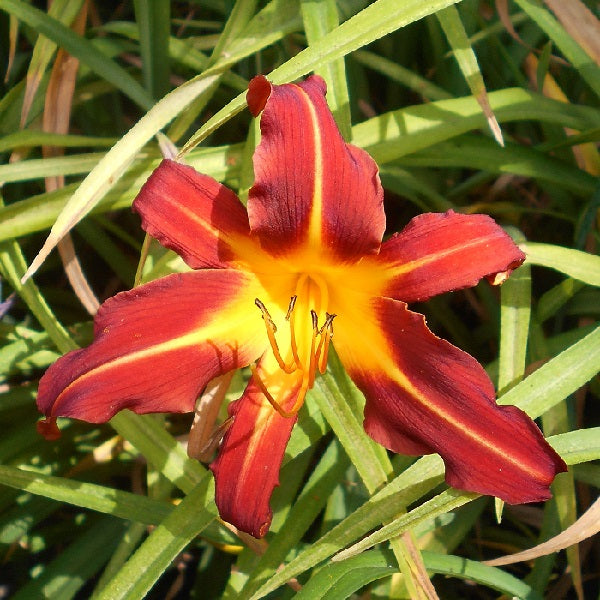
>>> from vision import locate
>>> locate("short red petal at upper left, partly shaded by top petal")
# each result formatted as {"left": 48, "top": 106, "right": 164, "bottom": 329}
{"left": 133, "top": 160, "right": 249, "bottom": 269}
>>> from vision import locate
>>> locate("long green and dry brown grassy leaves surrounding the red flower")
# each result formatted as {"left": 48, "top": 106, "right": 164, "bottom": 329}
{"left": 0, "top": 0, "right": 600, "bottom": 599}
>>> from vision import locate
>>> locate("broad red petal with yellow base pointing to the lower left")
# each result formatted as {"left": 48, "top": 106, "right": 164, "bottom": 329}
{"left": 37, "top": 270, "right": 266, "bottom": 423}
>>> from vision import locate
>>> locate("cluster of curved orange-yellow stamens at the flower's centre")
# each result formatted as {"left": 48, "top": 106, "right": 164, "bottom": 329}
{"left": 250, "top": 290, "right": 336, "bottom": 418}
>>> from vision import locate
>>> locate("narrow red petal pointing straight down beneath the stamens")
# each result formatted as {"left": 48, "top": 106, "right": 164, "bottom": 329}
{"left": 210, "top": 352, "right": 302, "bottom": 538}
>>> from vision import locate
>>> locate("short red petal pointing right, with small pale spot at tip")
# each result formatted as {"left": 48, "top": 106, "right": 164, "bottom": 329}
{"left": 377, "top": 210, "right": 525, "bottom": 302}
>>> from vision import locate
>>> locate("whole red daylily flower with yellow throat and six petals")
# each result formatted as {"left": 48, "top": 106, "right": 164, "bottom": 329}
{"left": 38, "top": 76, "right": 566, "bottom": 537}
